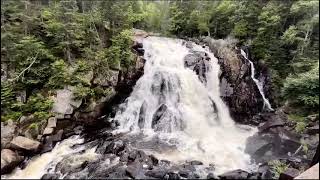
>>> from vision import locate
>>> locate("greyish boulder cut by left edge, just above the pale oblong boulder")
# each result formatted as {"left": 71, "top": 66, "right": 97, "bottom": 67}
{"left": 1, "top": 121, "right": 17, "bottom": 149}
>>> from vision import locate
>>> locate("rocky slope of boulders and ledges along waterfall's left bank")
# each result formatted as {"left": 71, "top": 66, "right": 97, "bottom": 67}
{"left": 1, "top": 31, "right": 147, "bottom": 174}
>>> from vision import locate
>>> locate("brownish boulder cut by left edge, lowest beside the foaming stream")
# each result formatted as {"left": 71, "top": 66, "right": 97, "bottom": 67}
{"left": 1, "top": 149, "right": 24, "bottom": 174}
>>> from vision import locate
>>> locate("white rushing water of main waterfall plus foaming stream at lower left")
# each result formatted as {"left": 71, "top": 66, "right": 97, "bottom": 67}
{"left": 1, "top": 37, "right": 257, "bottom": 179}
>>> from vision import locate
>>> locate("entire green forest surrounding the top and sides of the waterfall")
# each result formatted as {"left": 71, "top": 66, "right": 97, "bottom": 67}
{"left": 1, "top": 0, "right": 319, "bottom": 126}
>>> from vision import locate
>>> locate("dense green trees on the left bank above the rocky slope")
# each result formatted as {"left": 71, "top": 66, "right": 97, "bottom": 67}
{"left": 1, "top": 0, "right": 145, "bottom": 124}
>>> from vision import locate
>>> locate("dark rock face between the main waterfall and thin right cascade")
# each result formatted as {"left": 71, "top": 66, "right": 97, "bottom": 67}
{"left": 203, "top": 38, "right": 270, "bottom": 125}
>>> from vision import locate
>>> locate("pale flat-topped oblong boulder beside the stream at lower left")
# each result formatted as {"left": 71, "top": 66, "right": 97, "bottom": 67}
{"left": 10, "top": 136, "right": 40, "bottom": 152}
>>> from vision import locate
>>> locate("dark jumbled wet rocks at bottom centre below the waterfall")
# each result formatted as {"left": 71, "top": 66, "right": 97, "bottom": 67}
{"left": 47, "top": 132, "right": 215, "bottom": 179}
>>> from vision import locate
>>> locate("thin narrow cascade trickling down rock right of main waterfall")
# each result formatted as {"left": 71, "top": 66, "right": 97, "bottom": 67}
{"left": 241, "top": 49, "right": 274, "bottom": 111}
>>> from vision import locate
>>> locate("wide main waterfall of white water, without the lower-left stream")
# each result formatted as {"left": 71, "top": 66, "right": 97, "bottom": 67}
{"left": 114, "top": 37, "right": 255, "bottom": 173}
